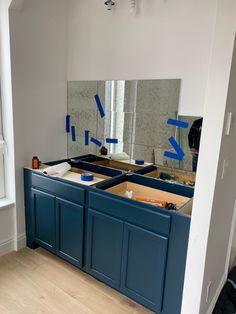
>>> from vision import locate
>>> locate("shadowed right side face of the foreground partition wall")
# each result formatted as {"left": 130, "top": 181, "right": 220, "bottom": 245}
{"left": 201, "top": 33, "right": 236, "bottom": 311}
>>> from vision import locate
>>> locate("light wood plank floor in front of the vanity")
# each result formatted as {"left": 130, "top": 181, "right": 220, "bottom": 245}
{"left": 0, "top": 248, "right": 151, "bottom": 314}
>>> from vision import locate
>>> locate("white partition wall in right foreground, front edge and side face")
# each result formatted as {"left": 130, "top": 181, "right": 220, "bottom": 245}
{"left": 182, "top": 0, "right": 236, "bottom": 314}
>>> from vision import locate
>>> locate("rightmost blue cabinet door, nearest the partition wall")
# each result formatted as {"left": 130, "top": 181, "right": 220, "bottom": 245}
{"left": 121, "top": 223, "right": 168, "bottom": 313}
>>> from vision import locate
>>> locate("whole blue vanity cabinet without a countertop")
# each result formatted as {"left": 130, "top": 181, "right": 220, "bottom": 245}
{"left": 25, "top": 166, "right": 193, "bottom": 314}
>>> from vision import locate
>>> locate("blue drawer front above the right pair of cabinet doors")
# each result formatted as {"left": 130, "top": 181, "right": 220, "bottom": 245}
{"left": 89, "top": 192, "right": 171, "bottom": 236}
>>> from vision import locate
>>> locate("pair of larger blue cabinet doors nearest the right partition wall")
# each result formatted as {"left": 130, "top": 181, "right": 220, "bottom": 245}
{"left": 86, "top": 205, "right": 168, "bottom": 313}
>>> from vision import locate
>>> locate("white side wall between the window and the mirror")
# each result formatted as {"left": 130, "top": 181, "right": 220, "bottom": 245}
{"left": 10, "top": 0, "right": 67, "bottom": 244}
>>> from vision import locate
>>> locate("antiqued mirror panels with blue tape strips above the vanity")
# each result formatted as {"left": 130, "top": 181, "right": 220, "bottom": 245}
{"left": 68, "top": 79, "right": 202, "bottom": 177}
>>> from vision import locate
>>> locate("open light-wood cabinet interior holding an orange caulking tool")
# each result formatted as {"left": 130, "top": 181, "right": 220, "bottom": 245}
{"left": 106, "top": 181, "right": 192, "bottom": 215}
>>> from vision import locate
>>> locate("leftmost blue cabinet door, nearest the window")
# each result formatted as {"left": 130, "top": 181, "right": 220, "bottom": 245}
{"left": 32, "top": 189, "right": 55, "bottom": 252}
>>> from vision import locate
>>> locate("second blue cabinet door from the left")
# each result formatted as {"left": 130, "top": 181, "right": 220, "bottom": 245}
{"left": 56, "top": 198, "right": 84, "bottom": 267}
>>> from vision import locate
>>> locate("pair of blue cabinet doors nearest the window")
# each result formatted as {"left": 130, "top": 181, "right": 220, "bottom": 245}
{"left": 32, "top": 188, "right": 84, "bottom": 267}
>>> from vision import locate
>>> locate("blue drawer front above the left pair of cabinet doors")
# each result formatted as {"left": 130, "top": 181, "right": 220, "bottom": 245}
{"left": 32, "top": 173, "right": 85, "bottom": 204}
